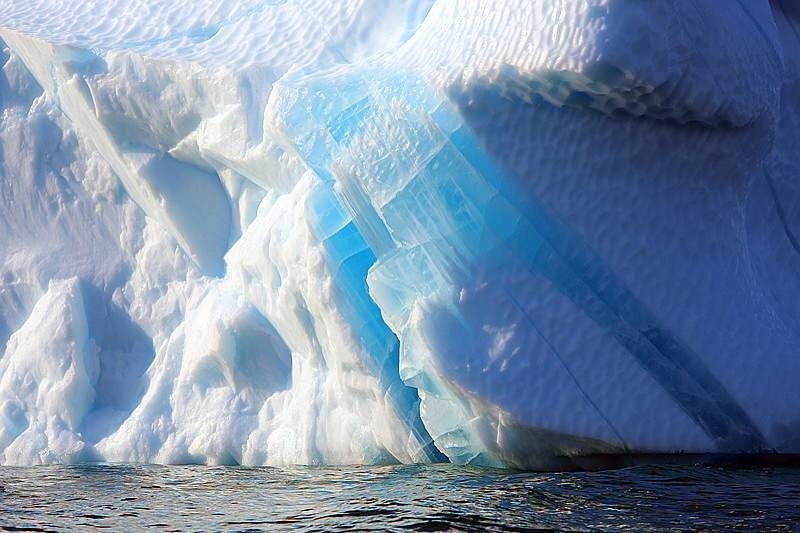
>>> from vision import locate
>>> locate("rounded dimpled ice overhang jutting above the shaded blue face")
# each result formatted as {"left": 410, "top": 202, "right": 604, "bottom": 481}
{"left": 399, "top": 0, "right": 782, "bottom": 126}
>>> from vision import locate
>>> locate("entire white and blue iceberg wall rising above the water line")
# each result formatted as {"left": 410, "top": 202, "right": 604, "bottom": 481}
{"left": 0, "top": 0, "right": 800, "bottom": 468}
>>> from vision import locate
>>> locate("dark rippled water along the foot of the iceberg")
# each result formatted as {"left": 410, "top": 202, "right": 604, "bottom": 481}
{"left": 0, "top": 465, "right": 800, "bottom": 531}
